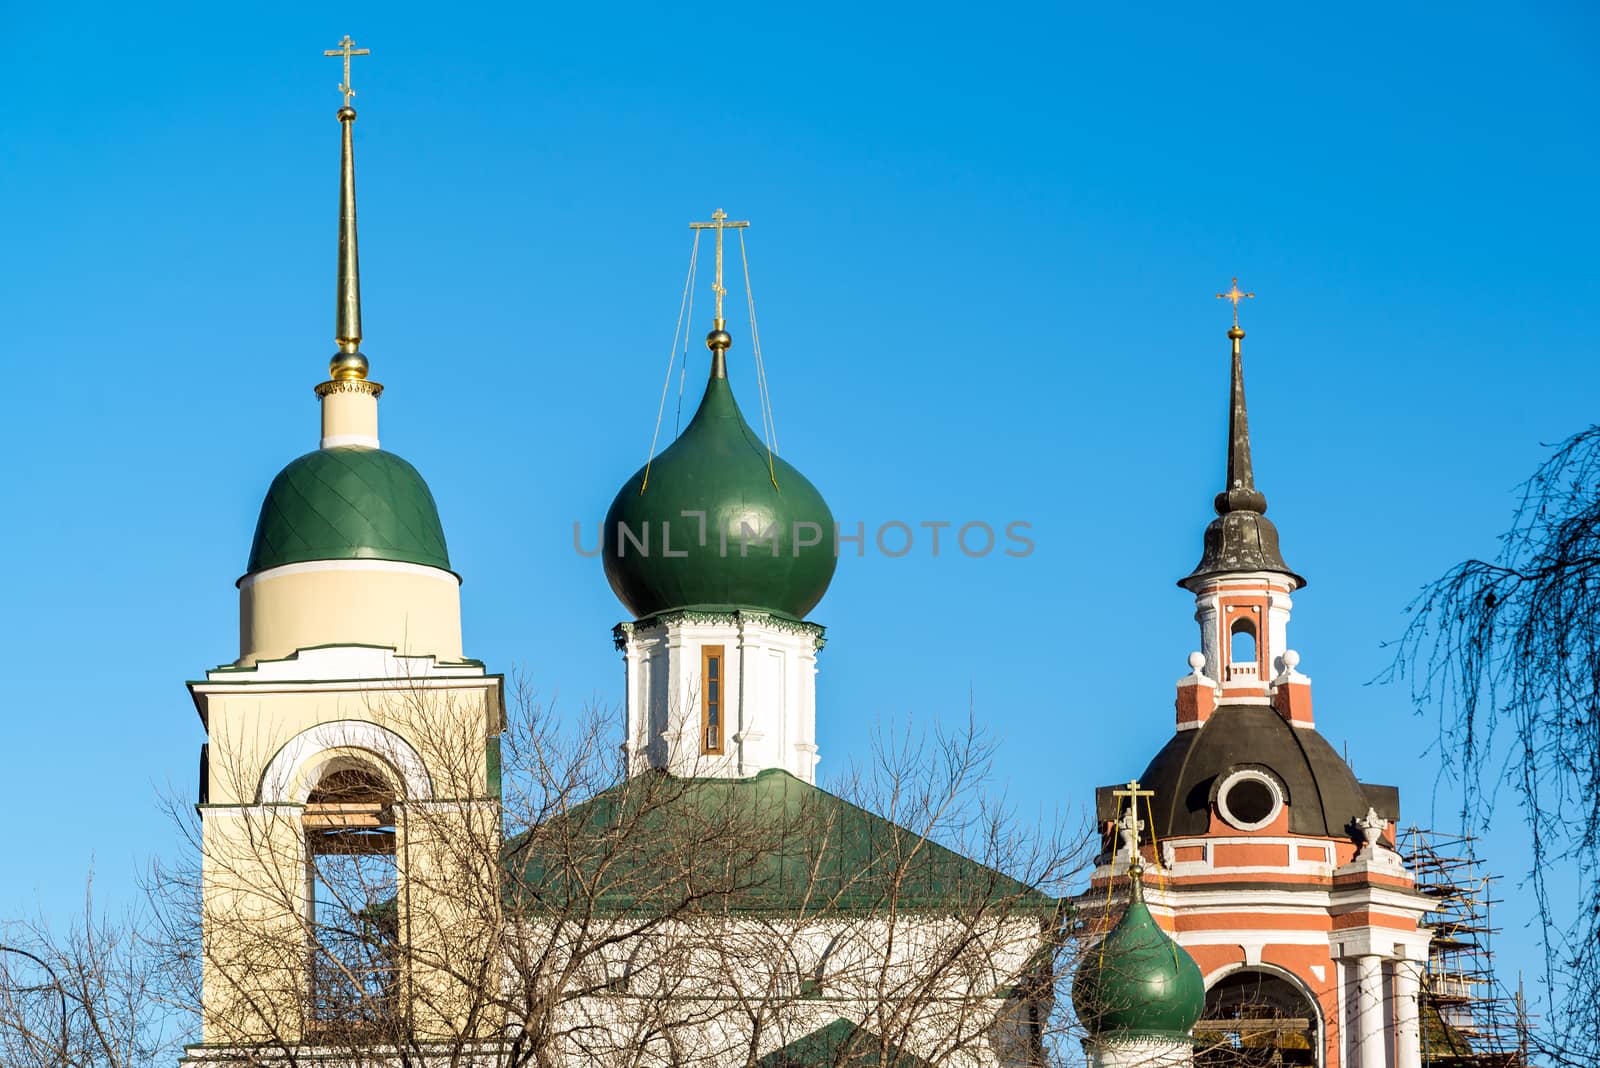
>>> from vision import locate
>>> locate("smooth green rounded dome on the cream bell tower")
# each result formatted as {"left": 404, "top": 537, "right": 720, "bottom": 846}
{"left": 246, "top": 446, "right": 450, "bottom": 572}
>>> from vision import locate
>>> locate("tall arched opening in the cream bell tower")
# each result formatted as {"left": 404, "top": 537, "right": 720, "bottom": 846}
{"left": 301, "top": 766, "right": 400, "bottom": 1028}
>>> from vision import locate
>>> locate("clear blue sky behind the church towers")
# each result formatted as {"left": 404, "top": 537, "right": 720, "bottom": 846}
{"left": 0, "top": 3, "right": 1600, "bottom": 1010}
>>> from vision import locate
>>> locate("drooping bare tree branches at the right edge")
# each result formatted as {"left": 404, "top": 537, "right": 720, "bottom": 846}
{"left": 1392, "top": 427, "right": 1600, "bottom": 1068}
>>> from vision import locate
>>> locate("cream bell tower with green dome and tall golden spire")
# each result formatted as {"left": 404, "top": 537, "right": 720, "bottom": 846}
{"left": 189, "top": 37, "right": 504, "bottom": 1063}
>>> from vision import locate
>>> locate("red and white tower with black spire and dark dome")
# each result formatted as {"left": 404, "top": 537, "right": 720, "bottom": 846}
{"left": 1091, "top": 280, "right": 1429, "bottom": 1068}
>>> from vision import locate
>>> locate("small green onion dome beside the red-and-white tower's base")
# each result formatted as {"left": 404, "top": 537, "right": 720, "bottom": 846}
{"left": 1072, "top": 881, "right": 1205, "bottom": 1039}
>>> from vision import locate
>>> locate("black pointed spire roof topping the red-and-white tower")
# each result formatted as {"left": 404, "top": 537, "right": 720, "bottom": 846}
{"left": 1178, "top": 326, "right": 1306, "bottom": 588}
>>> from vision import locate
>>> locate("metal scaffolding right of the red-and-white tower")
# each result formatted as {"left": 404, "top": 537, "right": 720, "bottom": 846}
{"left": 1398, "top": 827, "right": 1528, "bottom": 1068}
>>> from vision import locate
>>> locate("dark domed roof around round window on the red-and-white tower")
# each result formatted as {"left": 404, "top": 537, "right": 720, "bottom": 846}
{"left": 1096, "top": 705, "right": 1400, "bottom": 838}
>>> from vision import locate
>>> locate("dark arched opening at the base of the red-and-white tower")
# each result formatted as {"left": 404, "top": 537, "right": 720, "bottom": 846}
{"left": 1195, "top": 967, "right": 1322, "bottom": 1068}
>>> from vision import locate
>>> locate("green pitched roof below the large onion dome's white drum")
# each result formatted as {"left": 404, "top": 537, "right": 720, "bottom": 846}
{"left": 506, "top": 769, "right": 1056, "bottom": 915}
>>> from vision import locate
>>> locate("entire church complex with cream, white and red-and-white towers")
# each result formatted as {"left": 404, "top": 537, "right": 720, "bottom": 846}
{"left": 184, "top": 38, "right": 1427, "bottom": 1068}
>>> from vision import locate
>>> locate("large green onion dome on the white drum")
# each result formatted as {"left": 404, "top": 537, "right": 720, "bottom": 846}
{"left": 602, "top": 376, "right": 837, "bottom": 619}
